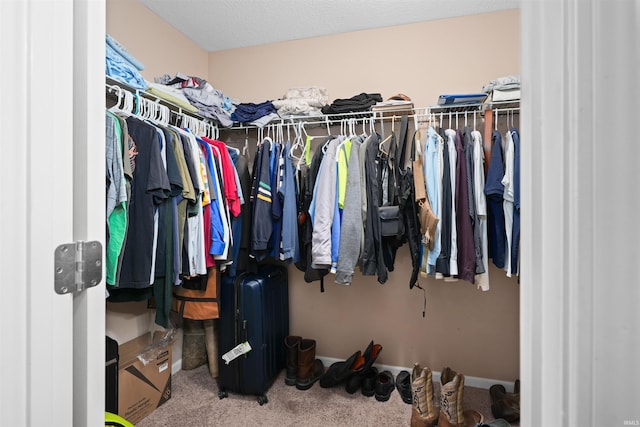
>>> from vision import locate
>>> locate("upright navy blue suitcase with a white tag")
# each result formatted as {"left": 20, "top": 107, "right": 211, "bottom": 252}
{"left": 218, "top": 265, "right": 289, "bottom": 405}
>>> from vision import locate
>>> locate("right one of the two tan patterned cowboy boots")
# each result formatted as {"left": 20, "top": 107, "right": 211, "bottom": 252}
{"left": 438, "top": 370, "right": 484, "bottom": 427}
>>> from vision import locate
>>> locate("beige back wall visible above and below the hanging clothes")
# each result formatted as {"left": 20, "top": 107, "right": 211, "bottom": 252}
{"left": 209, "top": 10, "right": 520, "bottom": 381}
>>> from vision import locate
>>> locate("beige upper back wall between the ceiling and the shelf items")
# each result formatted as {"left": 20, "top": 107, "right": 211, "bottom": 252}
{"left": 209, "top": 10, "right": 520, "bottom": 106}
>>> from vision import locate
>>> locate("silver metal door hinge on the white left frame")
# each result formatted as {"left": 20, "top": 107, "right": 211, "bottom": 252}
{"left": 54, "top": 241, "right": 102, "bottom": 294}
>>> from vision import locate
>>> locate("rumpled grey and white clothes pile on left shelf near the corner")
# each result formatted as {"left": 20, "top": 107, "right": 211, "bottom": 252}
{"left": 155, "top": 73, "right": 233, "bottom": 127}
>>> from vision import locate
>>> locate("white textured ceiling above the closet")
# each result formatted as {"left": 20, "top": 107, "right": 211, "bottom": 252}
{"left": 137, "top": 0, "right": 520, "bottom": 52}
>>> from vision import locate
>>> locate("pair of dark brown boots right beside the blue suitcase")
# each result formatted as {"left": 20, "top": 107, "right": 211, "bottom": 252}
{"left": 284, "top": 335, "right": 324, "bottom": 390}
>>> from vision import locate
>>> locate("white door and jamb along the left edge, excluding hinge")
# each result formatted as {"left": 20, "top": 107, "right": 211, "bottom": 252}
{"left": 0, "top": 0, "right": 105, "bottom": 427}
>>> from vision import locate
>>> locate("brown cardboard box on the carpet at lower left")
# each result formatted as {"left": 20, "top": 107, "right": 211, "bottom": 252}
{"left": 118, "top": 332, "right": 171, "bottom": 424}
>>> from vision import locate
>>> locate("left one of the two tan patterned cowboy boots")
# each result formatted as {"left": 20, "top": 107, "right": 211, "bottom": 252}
{"left": 411, "top": 363, "right": 439, "bottom": 427}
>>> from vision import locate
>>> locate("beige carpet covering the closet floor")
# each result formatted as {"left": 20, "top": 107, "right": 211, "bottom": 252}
{"left": 137, "top": 365, "right": 520, "bottom": 427}
